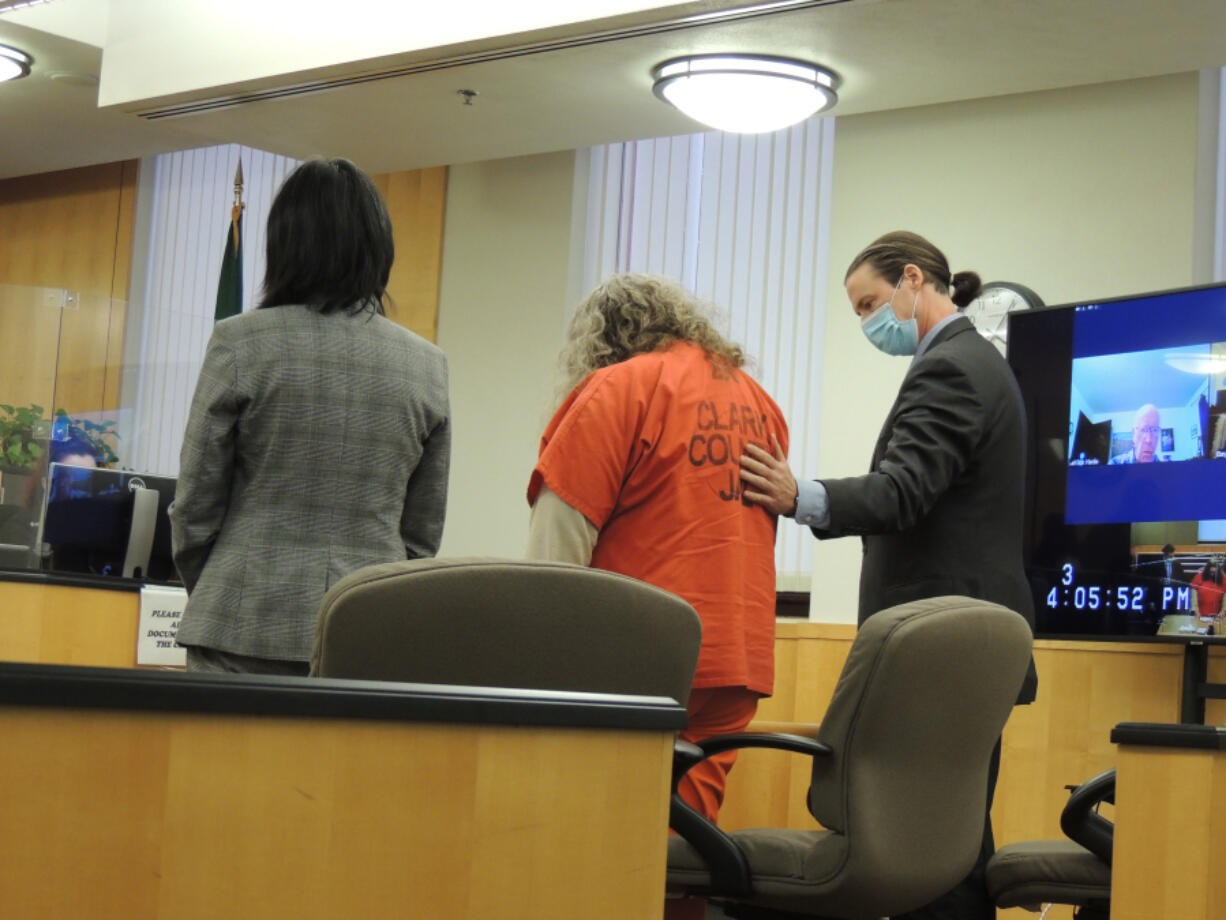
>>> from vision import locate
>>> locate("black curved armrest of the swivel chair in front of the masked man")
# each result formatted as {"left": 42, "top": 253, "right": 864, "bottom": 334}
{"left": 668, "top": 732, "right": 834, "bottom": 898}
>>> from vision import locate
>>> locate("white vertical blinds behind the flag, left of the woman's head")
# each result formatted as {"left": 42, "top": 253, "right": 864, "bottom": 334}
{"left": 120, "top": 144, "right": 298, "bottom": 476}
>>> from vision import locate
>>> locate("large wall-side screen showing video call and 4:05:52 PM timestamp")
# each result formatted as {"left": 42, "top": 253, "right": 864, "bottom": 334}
{"left": 1008, "top": 285, "right": 1226, "bottom": 642}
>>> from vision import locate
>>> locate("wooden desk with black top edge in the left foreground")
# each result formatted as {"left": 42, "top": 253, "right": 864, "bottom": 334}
{"left": 0, "top": 664, "right": 685, "bottom": 920}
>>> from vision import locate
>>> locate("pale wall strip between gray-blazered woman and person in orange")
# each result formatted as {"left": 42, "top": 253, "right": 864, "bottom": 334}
{"left": 439, "top": 151, "right": 575, "bottom": 557}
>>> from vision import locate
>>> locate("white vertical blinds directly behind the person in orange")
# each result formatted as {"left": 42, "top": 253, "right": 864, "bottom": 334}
{"left": 581, "top": 118, "right": 835, "bottom": 590}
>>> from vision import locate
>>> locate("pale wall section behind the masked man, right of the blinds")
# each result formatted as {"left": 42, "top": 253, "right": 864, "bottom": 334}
{"left": 797, "top": 74, "right": 1198, "bottom": 622}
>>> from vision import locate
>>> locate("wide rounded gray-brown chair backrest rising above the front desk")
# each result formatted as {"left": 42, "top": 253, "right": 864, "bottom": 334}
{"left": 311, "top": 558, "right": 702, "bottom": 704}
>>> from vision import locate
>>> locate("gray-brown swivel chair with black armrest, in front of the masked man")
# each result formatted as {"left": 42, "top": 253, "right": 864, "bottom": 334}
{"left": 668, "top": 597, "right": 1031, "bottom": 920}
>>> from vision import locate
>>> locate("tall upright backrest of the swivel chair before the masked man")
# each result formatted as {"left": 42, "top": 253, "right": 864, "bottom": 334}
{"left": 809, "top": 597, "right": 1032, "bottom": 916}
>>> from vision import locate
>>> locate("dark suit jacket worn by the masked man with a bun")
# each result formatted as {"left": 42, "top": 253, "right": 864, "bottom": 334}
{"left": 813, "top": 318, "right": 1037, "bottom": 703}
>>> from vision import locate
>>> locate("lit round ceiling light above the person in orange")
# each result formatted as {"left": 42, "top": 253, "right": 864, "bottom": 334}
{"left": 651, "top": 54, "right": 839, "bottom": 134}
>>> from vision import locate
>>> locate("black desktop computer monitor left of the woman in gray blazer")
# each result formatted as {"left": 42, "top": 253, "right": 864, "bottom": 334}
{"left": 40, "top": 464, "right": 179, "bottom": 584}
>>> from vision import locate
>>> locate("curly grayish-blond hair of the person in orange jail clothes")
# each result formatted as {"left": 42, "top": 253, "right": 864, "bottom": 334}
{"left": 558, "top": 274, "right": 745, "bottom": 401}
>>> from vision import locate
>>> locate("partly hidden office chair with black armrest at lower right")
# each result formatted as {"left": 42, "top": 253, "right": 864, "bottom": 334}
{"left": 986, "top": 770, "right": 1116, "bottom": 920}
